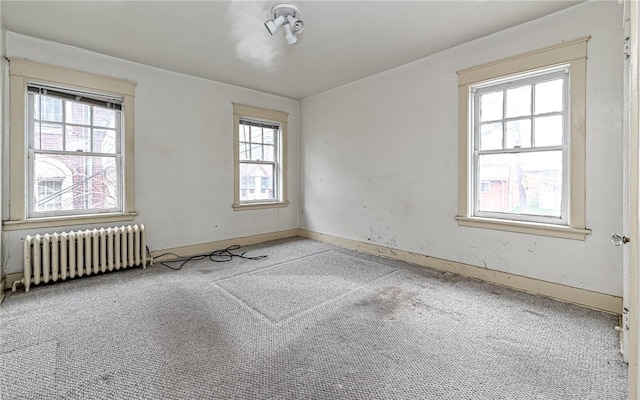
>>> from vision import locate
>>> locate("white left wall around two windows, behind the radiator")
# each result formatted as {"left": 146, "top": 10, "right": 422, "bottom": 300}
{"left": 1, "top": 32, "right": 299, "bottom": 273}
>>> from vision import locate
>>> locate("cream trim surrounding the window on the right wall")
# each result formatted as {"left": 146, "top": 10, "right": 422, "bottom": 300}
{"left": 455, "top": 36, "right": 591, "bottom": 240}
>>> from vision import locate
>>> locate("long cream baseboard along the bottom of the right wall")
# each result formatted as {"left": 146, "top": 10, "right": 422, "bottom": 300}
{"left": 298, "top": 229, "right": 622, "bottom": 315}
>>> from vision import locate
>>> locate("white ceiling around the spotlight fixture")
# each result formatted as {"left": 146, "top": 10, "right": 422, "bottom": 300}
{"left": 1, "top": 0, "right": 581, "bottom": 99}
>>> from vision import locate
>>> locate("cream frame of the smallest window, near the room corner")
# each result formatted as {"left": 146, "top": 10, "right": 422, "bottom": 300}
{"left": 232, "top": 103, "right": 289, "bottom": 211}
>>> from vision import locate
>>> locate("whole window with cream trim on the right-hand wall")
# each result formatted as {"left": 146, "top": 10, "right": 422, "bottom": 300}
{"left": 456, "top": 38, "right": 590, "bottom": 240}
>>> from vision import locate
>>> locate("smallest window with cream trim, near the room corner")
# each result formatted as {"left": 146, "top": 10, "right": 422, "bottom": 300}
{"left": 233, "top": 104, "right": 288, "bottom": 210}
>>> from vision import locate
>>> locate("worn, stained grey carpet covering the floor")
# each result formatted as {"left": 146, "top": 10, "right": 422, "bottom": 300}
{"left": 0, "top": 239, "right": 627, "bottom": 400}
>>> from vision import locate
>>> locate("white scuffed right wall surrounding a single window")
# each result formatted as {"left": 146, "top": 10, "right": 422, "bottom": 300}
{"left": 300, "top": 2, "right": 623, "bottom": 296}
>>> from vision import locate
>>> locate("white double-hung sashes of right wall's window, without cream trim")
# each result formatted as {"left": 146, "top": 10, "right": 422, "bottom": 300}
{"left": 471, "top": 66, "right": 569, "bottom": 225}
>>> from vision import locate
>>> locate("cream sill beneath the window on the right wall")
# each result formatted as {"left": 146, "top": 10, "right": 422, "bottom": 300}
{"left": 455, "top": 216, "right": 591, "bottom": 240}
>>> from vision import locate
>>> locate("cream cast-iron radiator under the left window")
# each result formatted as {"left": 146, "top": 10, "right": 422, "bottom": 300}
{"left": 23, "top": 225, "right": 147, "bottom": 292}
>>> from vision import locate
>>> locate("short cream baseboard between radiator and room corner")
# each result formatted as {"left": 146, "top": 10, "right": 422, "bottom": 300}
{"left": 151, "top": 229, "right": 298, "bottom": 261}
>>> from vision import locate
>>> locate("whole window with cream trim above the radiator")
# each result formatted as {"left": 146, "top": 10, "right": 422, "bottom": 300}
{"left": 4, "top": 60, "right": 136, "bottom": 230}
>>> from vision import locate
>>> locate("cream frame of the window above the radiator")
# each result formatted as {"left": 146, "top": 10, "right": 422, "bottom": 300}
{"left": 4, "top": 59, "right": 137, "bottom": 230}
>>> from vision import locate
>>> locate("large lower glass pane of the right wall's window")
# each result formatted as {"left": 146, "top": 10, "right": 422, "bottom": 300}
{"left": 476, "top": 151, "right": 562, "bottom": 217}
